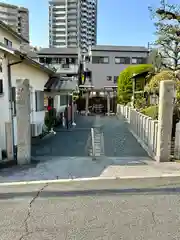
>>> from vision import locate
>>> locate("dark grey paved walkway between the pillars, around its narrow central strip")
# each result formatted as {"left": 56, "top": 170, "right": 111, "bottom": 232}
{"left": 32, "top": 116, "right": 147, "bottom": 157}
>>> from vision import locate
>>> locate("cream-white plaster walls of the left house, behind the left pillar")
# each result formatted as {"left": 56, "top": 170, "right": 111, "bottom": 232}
{"left": 0, "top": 53, "right": 49, "bottom": 149}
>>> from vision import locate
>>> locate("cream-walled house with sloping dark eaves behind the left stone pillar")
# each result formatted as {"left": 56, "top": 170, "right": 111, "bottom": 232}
{"left": 0, "top": 21, "right": 54, "bottom": 158}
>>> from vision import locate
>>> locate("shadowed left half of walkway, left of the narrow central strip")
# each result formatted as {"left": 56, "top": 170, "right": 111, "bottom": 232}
{"left": 32, "top": 116, "right": 94, "bottom": 157}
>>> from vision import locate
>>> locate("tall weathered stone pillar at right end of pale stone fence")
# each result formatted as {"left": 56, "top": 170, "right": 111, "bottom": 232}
{"left": 156, "top": 80, "right": 175, "bottom": 162}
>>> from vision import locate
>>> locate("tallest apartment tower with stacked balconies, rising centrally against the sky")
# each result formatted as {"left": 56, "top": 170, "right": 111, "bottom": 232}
{"left": 49, "top": 0, "right": 97, "bottom": 51}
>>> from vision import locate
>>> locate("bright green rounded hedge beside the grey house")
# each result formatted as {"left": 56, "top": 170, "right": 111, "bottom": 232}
{"left": 118, "top": 64, "right": 153, "bottom": 104}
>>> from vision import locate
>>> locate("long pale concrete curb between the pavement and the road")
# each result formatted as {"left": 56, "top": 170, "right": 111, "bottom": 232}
{"left": 0, "top": 174, "right": 180, "bottom": 187}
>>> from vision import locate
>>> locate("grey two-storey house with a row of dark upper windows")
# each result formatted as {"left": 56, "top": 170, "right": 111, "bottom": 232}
{"left": 84, "top": 45, "right": 149, "bottom": 90}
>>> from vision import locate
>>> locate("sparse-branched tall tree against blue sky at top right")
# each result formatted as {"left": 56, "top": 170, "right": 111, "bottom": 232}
{"left": 150, "top": 0, "right": 180, "bottom": 71}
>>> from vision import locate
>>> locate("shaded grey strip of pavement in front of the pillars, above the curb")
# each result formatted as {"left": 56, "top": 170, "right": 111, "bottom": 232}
{"left": 0, "top": 156, "right": 149, "bottom": 182}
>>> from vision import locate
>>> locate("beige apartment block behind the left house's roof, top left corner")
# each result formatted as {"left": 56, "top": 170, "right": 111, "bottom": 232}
{"left": 0, "top": 2, "right": 29, "bottom": 40}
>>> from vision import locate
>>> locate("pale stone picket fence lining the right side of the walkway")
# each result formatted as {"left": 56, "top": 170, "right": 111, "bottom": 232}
{"left": 117, "top": 104, "right": 158, "bottom": 159}
